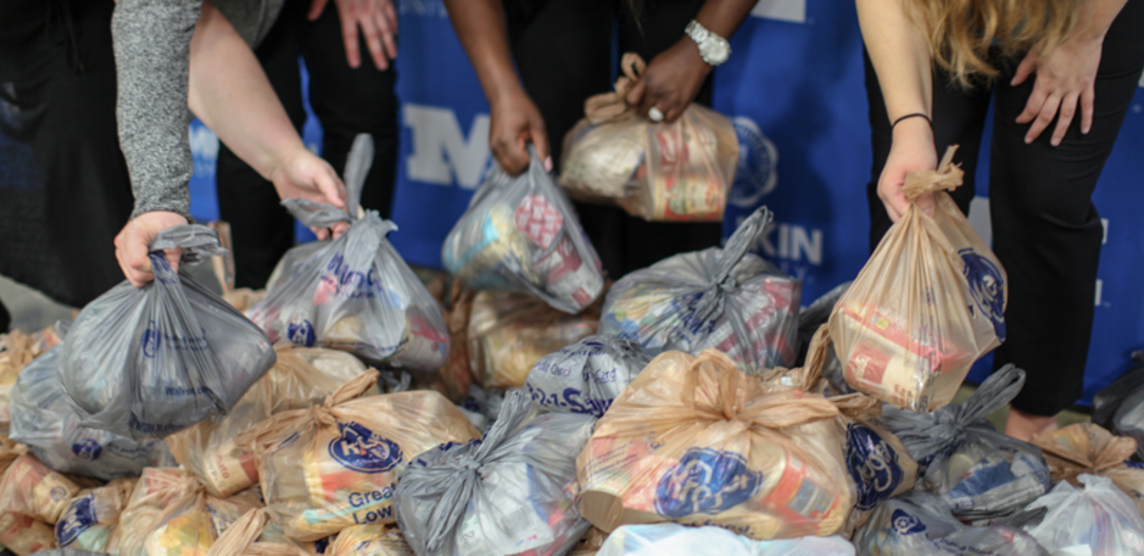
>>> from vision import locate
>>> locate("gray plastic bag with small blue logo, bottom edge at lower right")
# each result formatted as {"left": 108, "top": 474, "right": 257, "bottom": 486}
{"left": 853, "top": 491, "right": 1047, "bottom": 556}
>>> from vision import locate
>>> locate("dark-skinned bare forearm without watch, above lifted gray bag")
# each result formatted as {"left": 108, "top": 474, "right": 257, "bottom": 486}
{"left": 445, "top": 0, "right": 524, "bottom": 104}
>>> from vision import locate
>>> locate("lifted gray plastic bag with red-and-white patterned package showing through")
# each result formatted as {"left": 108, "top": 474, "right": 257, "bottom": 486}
{"left": 440, "top": 146, "right": 604, "bottom": 313}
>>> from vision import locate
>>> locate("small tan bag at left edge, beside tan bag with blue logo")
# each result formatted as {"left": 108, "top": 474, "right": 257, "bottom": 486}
{"left": 0, "top": 454, "right": 80, "bottom": 523}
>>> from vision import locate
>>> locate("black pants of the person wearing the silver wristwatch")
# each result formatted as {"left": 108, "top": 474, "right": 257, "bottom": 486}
{"left": 505, "top": 0, "right": 723, "bottom": 279}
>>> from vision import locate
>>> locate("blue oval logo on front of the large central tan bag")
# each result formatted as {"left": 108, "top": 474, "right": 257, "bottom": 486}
{"left": 656, "top": 448, "right": 763, "bottom": 518}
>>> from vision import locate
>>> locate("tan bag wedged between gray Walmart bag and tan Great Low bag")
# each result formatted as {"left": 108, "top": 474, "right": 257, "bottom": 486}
{"left": 167, "top": 344, "right": 378, "bottom": 498}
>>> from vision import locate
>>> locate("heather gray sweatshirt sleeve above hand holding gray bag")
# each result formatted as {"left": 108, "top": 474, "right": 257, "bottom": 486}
{"left": 111, "top": 0, "right": 202, "bottom": 219}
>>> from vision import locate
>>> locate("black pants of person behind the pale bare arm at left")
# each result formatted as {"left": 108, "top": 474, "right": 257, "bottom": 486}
{"left": 216, "top": 0, "right": 398, "bottom": 288}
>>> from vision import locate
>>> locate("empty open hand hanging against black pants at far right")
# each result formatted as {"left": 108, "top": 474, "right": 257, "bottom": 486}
{"left": 1009, "top": 33, "right": 1104, "bottom": 146}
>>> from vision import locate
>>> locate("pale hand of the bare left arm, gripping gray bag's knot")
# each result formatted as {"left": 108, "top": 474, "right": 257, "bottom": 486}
{"left": 270, "top": 146, "right": 349, "bottom": 239}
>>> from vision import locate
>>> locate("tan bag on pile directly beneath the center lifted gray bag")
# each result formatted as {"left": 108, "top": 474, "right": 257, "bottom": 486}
{"left": 468, "top": 288, "right": 606, "bottom": 389}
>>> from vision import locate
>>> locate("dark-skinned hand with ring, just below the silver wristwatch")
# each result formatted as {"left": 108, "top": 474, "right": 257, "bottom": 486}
{"left": 626, "top": 37, "right": 712, "bottom": 121}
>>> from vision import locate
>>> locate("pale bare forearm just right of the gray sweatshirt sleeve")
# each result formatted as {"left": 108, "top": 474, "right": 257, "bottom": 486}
{"left": 188, "top": 2, "right": 305, "bottom": 180}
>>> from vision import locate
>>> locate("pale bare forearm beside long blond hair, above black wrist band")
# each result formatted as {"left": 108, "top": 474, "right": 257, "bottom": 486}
{"left": 857, "top": 0, "right": 934, "bottom": 121}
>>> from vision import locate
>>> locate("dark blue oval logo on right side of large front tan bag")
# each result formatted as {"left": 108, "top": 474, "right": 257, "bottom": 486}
{"left": 847, "top": 423, "right": 905, "bottom": 510}
